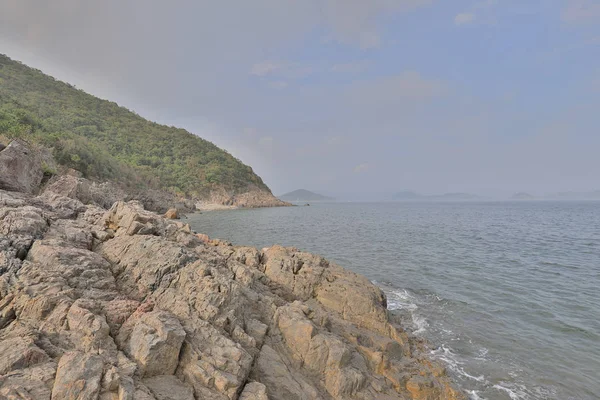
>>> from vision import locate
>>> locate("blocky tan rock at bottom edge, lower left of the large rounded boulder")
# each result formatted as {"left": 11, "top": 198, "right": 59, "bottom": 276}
{"left": 52, "top": 351, "right": 104, "bottom": 400}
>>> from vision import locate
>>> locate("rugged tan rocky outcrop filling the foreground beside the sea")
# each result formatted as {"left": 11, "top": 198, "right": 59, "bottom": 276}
{"left": 0, "top": 191, "right": 464, "bottom": 400}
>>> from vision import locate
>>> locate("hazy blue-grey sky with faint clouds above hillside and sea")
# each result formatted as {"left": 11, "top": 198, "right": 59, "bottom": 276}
{"left": 0, "top": 0, "right": 600, "bottom": 196}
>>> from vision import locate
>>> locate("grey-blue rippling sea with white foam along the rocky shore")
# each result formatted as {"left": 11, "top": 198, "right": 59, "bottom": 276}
{"left": 189, "top": 202, "right": 600, "bottom": 400}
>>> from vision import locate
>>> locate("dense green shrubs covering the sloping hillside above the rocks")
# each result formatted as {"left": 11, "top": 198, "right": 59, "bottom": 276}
{"left": 0, "top": 54, "right": 269, "bottom": 197}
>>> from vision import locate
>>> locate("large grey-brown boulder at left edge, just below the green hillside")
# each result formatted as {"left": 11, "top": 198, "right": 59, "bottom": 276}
{"left": 0, "top": 140, "right": 44, "bottom": 193}
